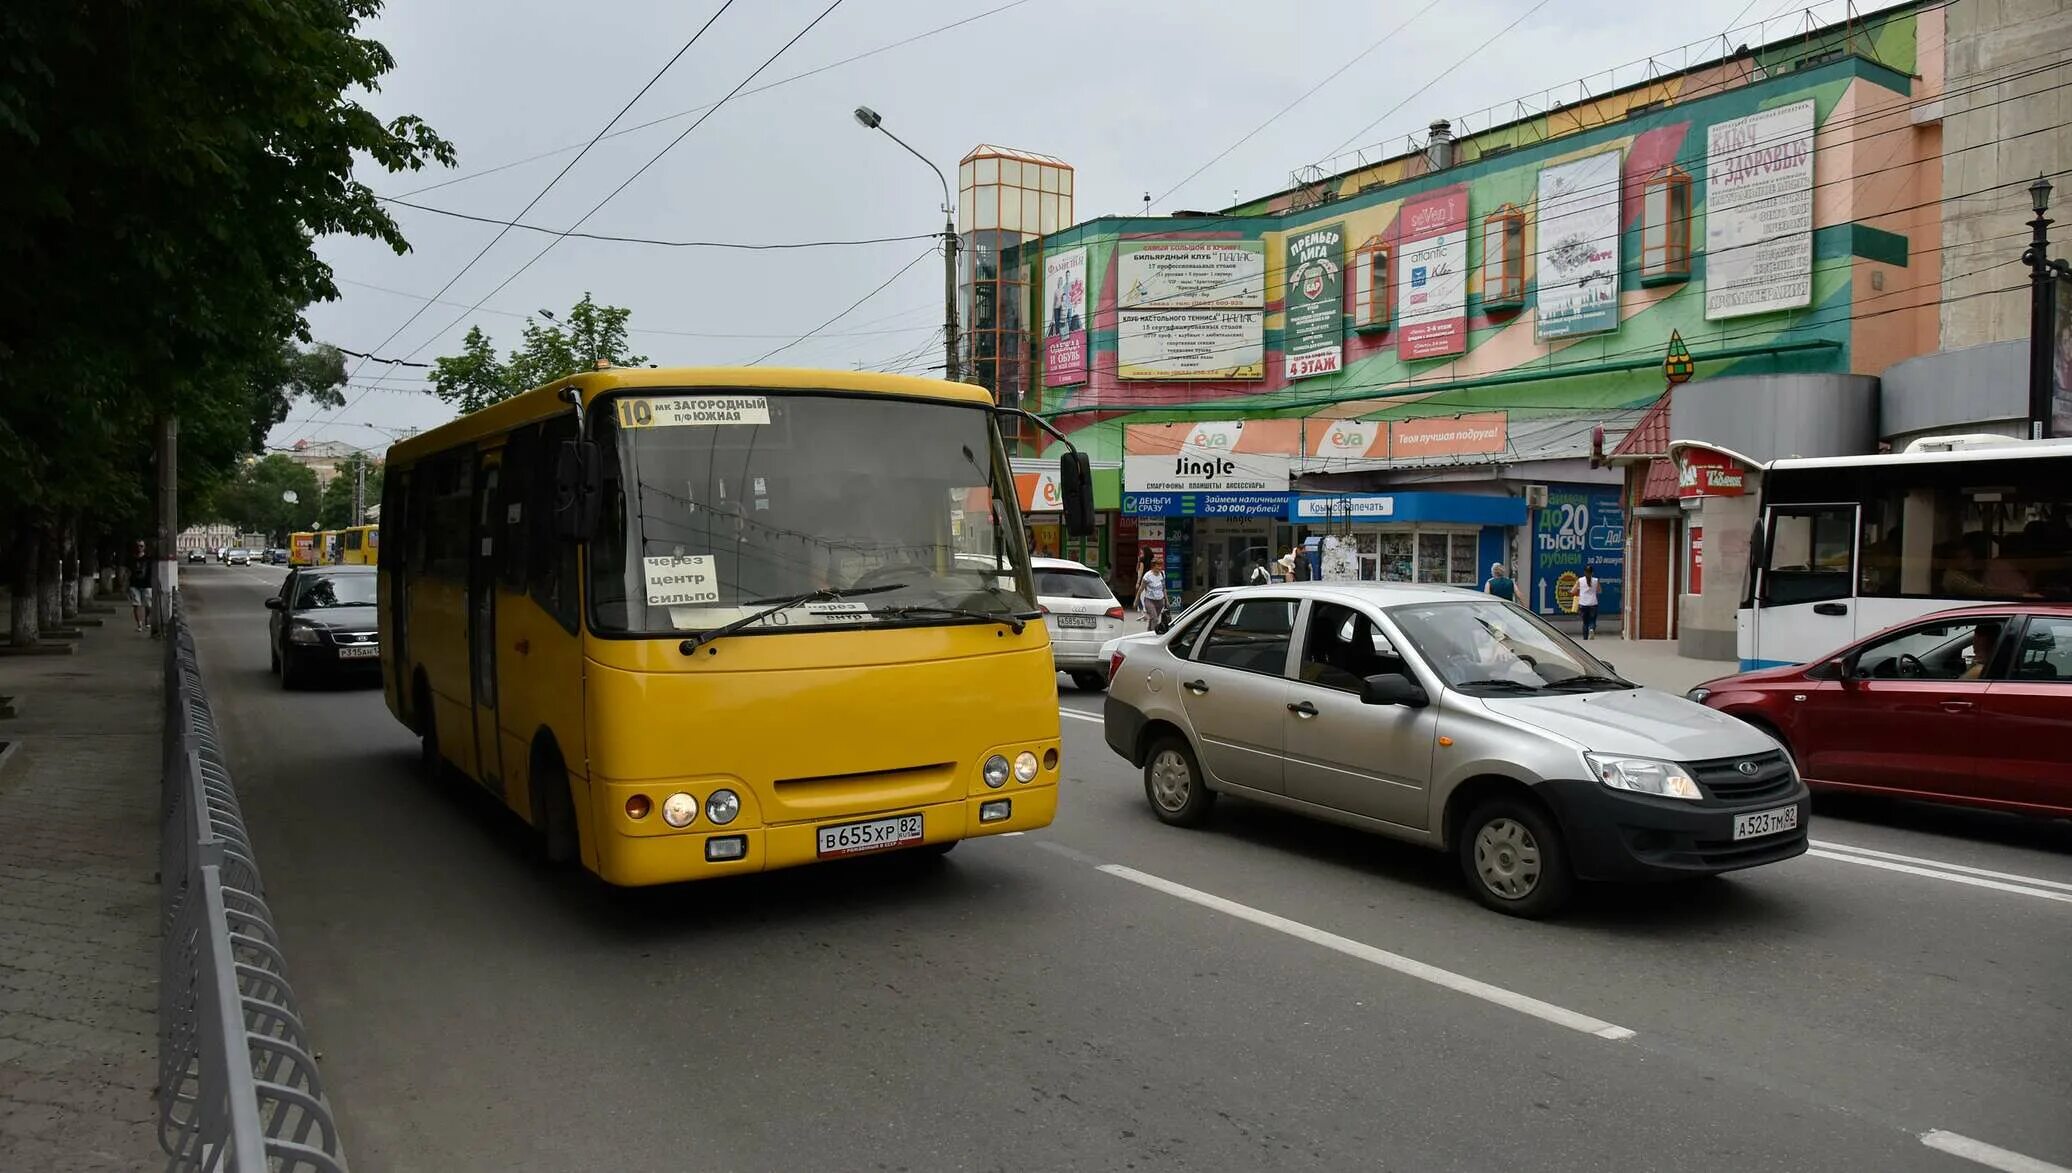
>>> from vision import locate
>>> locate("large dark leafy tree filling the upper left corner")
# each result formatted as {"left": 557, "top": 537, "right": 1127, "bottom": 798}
{"left": 0, "top": 0, "right": 454, "bottom": 642}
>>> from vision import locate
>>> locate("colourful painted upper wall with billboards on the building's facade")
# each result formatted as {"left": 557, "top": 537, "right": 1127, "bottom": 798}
{"left": 1015, "top": 15, "right": 1939, "bottom": 460}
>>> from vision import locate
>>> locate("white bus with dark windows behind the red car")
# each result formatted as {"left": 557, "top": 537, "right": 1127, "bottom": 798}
{"left": 1734, "top": 437, "right": 2072, "bottom": 669}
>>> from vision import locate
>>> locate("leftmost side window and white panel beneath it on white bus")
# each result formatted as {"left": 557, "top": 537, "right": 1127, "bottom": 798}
{"left": 1743, "top": 502, "right": 1859, "bottom": 667}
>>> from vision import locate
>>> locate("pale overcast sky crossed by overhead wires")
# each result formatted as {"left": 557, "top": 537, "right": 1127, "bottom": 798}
{"left": 271, "top": 0, "right": 1888, "bottom": 448}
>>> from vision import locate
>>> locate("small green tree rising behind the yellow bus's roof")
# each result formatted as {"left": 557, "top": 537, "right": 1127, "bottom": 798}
{"left": 431, "top": 292, "right": 646, "bottom": 412}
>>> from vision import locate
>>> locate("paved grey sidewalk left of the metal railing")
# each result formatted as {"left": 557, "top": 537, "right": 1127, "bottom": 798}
{"left": 0, "top": 611, "right": 166, "bottom": 1173}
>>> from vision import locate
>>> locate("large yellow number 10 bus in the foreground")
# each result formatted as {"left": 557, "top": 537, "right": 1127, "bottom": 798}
{"left": 379, "top": 369, "right": 1092, "bottom": 885}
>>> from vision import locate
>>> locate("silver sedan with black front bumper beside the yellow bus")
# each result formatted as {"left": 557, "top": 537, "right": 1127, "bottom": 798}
{"left": 1104, "top": 582, "right": 1807, "bottom": 916}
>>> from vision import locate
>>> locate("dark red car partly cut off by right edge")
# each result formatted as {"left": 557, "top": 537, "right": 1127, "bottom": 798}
{"left": 1689, "top": 603, "right": 2072, "bottom": 817}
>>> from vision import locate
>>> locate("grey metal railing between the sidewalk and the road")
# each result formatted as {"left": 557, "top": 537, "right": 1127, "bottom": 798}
{"left": 157, "top": 593, "right": 346, "bottom": 1173}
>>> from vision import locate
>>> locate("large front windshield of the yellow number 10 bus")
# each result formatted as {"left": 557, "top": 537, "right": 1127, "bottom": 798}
{"left": 591, "top": 390, "right": 1036, "bottom": 634}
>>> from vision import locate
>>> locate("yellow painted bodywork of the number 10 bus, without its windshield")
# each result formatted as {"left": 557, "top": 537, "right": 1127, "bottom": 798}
{"left": 379, "top": 367, "right": 1061, "bottom": 885}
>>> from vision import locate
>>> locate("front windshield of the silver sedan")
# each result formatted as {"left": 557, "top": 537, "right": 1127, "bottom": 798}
{"left": 1388, "top": 599, "right": 1624, "bottom": 692}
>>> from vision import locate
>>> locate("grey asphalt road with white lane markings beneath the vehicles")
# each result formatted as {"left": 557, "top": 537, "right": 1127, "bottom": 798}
{"left": 182, "top": 566, "right": 2072, "bottom": 1173}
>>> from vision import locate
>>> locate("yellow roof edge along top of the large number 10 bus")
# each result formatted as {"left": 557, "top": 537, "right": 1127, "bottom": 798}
{"left": 390, "top": 367, "right": 992, "bottom": 464}
